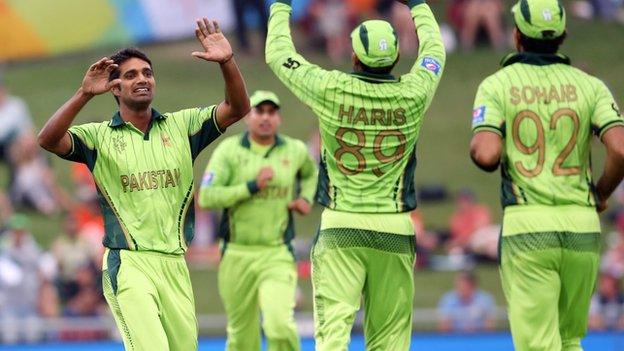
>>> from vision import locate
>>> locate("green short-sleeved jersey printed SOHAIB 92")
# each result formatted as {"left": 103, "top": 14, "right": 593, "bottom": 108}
{"left": 472, "top": 53, "right": 624, "bottom": 231}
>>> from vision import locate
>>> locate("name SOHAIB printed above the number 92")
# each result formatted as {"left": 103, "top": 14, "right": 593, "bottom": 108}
{"left": 509, "top": 84, "right": 578, "bottom": 105}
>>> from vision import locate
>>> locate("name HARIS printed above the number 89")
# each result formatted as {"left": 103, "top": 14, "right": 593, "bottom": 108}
{"left": 338, "top": 105, "right": 406, "bottom": 126}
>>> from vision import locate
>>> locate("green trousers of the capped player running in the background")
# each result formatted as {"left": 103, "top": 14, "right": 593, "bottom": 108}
{"left": 219, "top": 243, "right": 300, "bottom": 351}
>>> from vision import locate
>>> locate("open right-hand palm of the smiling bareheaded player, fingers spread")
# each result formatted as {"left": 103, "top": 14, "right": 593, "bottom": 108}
{"left": 191, "top": 17, "right": 234, "bottom": 63}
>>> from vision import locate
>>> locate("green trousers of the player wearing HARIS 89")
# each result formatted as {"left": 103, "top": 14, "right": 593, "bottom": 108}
{"left": 312, "top": 228, "right": 415, "bottom": 351}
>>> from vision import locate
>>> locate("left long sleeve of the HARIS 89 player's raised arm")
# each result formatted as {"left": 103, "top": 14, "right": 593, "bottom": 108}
{"left": 265, "top": 0, "right": 332, "bottom": 106}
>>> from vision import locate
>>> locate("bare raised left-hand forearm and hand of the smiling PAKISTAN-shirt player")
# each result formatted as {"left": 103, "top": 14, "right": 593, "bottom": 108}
{"left": 37, "top": 57, "right": 121, "bottom": 156}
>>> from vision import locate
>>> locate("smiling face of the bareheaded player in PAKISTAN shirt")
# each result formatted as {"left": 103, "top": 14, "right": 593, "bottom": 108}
{"left": 112, "top": 57, "right": 156, "bottom": 109}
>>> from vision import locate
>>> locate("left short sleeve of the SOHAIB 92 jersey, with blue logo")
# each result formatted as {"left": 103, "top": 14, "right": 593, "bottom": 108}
{"left": 472, "top": 79, "right": 505, "bottom": 137}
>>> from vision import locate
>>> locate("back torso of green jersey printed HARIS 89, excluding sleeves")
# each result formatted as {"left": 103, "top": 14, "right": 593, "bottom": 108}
{"left": 314, "top": 71, "right": 430, "bottom": 213}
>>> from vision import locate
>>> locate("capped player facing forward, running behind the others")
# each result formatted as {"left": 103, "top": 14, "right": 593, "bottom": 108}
{"left": 199, "top": 91, "right": 318, "bottom": 351}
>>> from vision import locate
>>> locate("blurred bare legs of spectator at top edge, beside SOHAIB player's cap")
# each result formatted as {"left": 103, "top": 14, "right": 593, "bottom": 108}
{"left": 448, "top": 0, "right": 506, "bottom": 50}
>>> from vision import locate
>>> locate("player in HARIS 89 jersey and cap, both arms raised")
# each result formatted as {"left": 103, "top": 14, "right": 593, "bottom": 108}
{"left": 265, "top": 0, "right": 446, "bottom": 351}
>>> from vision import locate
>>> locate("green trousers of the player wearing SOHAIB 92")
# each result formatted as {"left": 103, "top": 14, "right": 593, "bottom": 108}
{"left": 500, "top": 232, "right": 600, "bottom": 351}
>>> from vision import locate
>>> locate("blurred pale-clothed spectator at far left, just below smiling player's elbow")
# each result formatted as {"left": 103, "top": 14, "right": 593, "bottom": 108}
{"left": 9, "top": 132, "right": 69, "bottom": 215}
